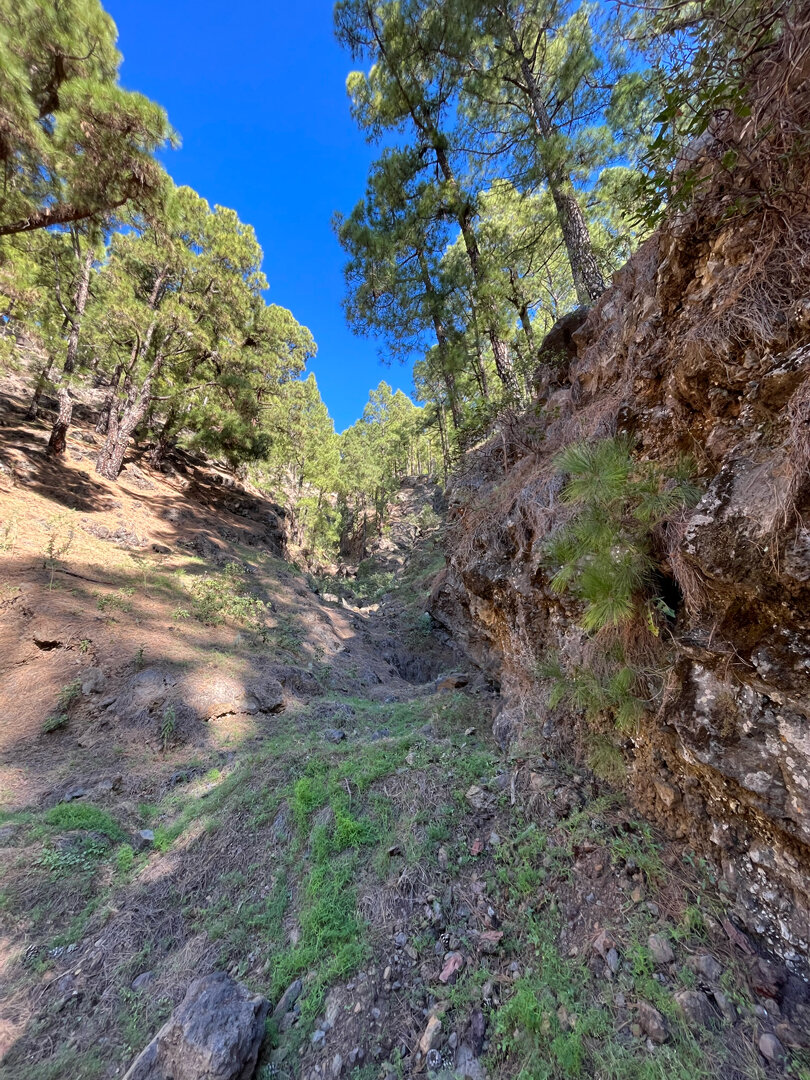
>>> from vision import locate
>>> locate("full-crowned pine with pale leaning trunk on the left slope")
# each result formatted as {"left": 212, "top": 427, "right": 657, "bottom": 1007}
{"left": 91, "top": 188, "right": 315, "bottom": 480}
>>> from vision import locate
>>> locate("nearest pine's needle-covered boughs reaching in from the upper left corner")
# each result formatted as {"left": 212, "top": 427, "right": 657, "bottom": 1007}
{"left": 0, "top": 0, "right": 174, "bottom": 235}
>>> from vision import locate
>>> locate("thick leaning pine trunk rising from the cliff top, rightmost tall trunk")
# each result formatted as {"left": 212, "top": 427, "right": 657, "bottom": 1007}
{"left": 507, "top": 14, "right": 607, "bottom": 306}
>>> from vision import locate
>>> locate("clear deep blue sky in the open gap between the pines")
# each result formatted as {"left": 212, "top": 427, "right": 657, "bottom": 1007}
{"left": 105, "top": 0, "right": 411, "bottom": 431}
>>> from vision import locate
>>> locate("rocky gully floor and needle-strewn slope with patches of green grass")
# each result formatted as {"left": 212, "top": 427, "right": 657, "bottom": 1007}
{"left": 0, "top": 388, "right": 810, "bottom": 1080}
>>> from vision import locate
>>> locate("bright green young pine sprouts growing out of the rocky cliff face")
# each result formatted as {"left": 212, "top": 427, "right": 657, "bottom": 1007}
{"left": 538, "top": 436, "right": 700, "bottom": 734}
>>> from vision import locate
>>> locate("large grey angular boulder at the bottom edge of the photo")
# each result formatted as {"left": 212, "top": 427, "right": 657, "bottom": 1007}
{"left": 124, "top": 972, "right": 270, "bottom": 1080}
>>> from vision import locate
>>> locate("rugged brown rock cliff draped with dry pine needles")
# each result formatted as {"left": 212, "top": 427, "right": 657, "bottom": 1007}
{"left": 433, "top": 27, "right": 810, "bottom": 971}
